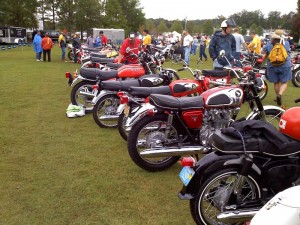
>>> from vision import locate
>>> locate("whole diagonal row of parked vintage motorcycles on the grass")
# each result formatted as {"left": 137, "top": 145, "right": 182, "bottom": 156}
{"left": 66, "top": 46, "right": 300, "bottom": 225}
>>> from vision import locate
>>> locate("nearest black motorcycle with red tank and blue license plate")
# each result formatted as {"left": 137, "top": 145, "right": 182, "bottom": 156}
{"left": 178, "top": 99, "right": 300, "bottom": 225}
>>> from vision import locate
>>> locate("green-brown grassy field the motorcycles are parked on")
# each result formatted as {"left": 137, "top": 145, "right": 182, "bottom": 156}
{"left": 0, "top": 46, "right": 300, "bottom": 225}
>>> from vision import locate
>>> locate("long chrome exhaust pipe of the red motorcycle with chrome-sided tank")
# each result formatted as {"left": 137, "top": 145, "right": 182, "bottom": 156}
{"left": 140, "top": 146, "right": 210, "bottom": 158}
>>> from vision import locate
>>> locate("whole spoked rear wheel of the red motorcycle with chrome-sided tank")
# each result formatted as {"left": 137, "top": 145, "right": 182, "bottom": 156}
{"left": 127, "top": 114, "right": 180, "bottom": 172}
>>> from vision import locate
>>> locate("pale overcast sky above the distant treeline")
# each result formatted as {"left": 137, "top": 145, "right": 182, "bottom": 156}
{"left": 140, "top": 0, "right": 297, "bottom": 20}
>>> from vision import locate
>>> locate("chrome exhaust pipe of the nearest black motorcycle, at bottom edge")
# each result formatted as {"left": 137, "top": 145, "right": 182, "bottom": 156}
{"left": 217, "top": 208, "right": 259, "bottom": 223}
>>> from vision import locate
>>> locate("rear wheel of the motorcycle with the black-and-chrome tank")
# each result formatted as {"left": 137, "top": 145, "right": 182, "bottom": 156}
{"left": 93, "top": 94, "right": 120, "bottom": 128}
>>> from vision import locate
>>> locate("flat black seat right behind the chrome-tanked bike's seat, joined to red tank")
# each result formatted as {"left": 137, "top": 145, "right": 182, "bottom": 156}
{"left": 128, "top": 86, "right": 172, "bottom": 98}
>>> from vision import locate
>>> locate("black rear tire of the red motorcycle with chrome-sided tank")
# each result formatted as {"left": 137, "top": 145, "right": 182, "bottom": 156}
{"left": 127, "top": 114, "right": 180, "bottom": 172}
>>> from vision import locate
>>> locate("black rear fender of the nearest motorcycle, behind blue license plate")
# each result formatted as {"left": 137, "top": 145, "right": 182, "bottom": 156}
{"left": 178, "top": 152, "right": 239, "bottom": 200}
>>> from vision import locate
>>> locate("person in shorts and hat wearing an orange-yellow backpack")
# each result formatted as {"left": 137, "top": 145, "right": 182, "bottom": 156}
{"left": 262, "top": 30, "right": 292, "bottom": 106}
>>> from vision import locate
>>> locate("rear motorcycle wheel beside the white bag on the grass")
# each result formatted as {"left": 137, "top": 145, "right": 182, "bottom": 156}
{"left": 70, "top": 80, "right": 96, "bottom": 112}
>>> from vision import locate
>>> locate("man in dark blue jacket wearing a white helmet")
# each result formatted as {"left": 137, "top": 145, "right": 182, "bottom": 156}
{"left": 208, "top": 19, "right": 236, "bottom": 69}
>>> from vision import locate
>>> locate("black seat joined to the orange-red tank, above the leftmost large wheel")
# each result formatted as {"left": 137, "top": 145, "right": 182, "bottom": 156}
{"left": 80, "top": 67, "right": 118, "bottom": 80}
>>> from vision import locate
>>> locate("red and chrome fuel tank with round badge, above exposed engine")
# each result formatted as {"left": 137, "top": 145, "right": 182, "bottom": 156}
{"left": 202, "top": 86, "right": 244, "bottom": 107}
